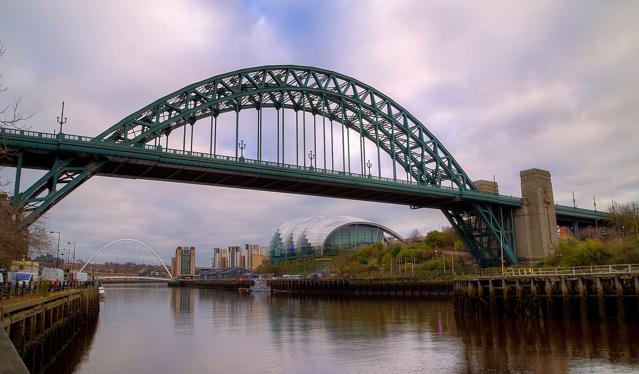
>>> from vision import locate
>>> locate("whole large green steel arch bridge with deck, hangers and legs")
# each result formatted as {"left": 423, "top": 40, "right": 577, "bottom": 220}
{"left": 0, "top": 65, "right": 605, "bottom": 265}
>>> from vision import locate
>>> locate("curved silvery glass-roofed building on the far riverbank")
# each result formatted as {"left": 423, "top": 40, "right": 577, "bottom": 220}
{"left": 269, "top": 216, "right": 403, "bottom": 264}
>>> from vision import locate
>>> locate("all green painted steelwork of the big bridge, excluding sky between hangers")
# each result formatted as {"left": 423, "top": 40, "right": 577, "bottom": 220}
{"left": 3, "top": 65, "right": 608, "bottom": 265}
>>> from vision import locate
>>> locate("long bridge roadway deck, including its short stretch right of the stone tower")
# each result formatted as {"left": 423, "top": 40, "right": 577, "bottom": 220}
{"left": 0, "top": 129, "right": 606, "bottom": 224}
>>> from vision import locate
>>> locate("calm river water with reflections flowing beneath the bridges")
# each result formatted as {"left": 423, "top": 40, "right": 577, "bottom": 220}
{"left": 50, "top": 285, "right": 639, "bottom": 374}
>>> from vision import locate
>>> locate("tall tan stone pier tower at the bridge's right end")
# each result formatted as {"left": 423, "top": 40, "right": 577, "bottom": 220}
{"left": 515, "top": 169, "right": 559, "bottom": 263}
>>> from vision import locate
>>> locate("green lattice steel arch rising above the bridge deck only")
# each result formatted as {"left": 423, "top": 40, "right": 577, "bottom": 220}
{"left": 96, "top": 65, "right": 474, "bottom": 190}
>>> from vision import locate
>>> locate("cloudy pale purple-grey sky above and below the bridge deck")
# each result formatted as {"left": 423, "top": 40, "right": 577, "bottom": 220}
{"left": 0, "top": 0, "right": 639, "bottom": 265}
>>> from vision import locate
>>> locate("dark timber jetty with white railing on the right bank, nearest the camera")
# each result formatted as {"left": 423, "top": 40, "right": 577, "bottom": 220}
{"left": 454, "top": 265, "right": 639, "bottom": 320}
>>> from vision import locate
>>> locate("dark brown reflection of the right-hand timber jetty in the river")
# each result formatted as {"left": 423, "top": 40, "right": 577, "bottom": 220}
{"left": 454, "top": 315, "right": 639, "bottom": 372}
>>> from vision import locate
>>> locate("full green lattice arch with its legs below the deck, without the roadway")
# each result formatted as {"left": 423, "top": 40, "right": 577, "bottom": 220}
{"left": 8, "top": 65, "right": 517, "bottom": 264}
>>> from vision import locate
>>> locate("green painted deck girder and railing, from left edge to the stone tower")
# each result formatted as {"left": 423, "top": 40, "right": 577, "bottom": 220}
{"left": 0, "top": 129, "right": 521, "bottom": 208}
